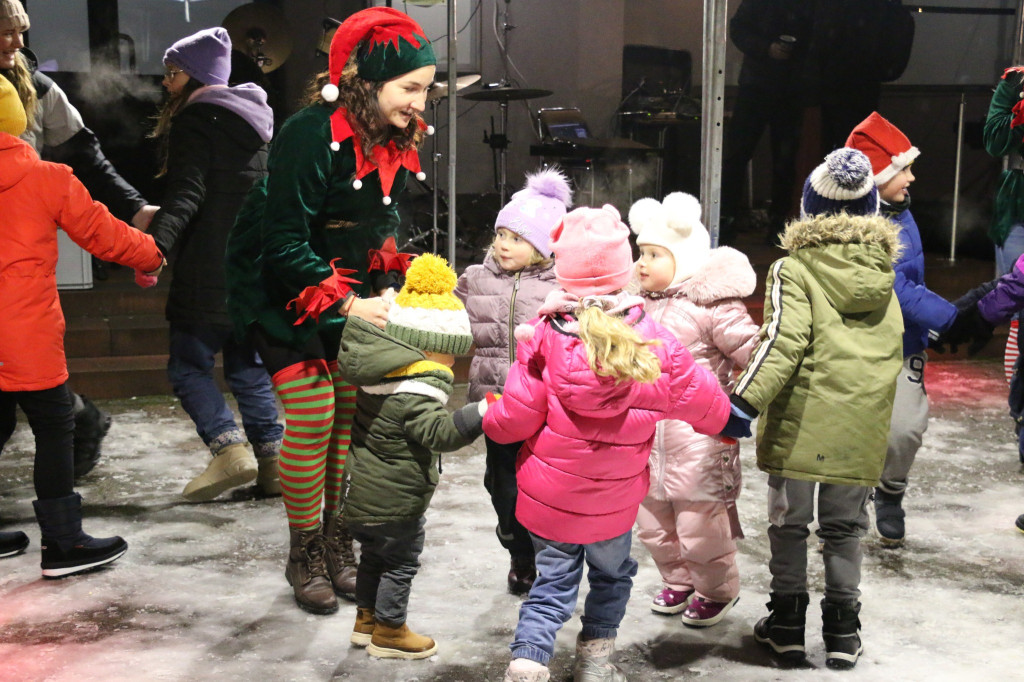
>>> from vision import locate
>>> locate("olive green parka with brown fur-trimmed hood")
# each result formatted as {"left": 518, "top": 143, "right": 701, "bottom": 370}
{"left": 732, "top": 214, "right": 903, "bottom": 485}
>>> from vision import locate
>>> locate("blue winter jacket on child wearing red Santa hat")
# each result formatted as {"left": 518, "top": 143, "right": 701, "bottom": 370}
{"left": 882, "top": 204, "right": 956, "bottom": 357}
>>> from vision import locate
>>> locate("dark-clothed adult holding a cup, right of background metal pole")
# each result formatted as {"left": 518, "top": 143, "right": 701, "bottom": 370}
{"left": 722, "top": 0, "right": 811, "bottom": 243}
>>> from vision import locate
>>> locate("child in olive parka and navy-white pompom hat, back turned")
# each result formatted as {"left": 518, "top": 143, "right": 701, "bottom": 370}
{"left": 731, "top": 147, "right": 903, "bottom": 669}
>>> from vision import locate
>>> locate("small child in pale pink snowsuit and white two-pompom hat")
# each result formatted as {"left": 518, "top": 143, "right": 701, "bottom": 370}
{"left": 630, "top": 191, "right": 758, "bottom": 628}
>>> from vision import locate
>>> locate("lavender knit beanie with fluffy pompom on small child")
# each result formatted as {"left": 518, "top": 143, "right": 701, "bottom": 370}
{"left": 495, "top": 168, "right": 572, "bottom": 258}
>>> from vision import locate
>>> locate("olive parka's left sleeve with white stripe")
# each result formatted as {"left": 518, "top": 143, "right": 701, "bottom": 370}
{"left": 733, "top": 258, "right": 811, "bottom": 413}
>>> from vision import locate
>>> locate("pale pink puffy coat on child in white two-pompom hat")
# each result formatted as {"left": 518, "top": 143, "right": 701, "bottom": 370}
{"left": 643, "top": 247, "right": 758, "bottom": 502}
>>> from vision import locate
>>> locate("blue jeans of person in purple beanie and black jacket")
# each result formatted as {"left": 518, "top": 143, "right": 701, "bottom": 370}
{"left": 167, "top": 323, "right": 284, "bottom": 456}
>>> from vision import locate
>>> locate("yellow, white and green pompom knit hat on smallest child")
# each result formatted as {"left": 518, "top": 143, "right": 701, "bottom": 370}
{"left": 385, "top": 253, "right": 473, "bottom": 355}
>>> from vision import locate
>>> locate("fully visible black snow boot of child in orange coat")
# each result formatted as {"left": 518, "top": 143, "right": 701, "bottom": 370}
{"left": 32, "top": 493, "right": 128, "bottom": 579}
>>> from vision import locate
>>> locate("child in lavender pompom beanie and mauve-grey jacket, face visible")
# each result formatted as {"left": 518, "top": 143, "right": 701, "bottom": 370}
{"left": 455, "top": 169, "right": 572, "bottom": 594}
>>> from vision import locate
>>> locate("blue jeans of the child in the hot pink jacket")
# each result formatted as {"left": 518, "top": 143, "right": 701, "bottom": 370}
{"left": 509, "top": 530, "right": 637, "bottom": 666}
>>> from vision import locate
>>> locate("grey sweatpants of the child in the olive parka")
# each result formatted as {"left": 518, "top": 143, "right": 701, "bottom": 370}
{"left": 768, "top": 476, "right": 871, "bottom": 602}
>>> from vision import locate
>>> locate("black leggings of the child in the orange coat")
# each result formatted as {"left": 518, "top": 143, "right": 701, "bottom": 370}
{"left": 0, "top": 384, "right": 75, "bottom": 500}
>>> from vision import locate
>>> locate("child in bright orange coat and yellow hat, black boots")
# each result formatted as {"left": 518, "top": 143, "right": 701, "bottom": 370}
{"left": 0, "top": 76, "right": 164, "bottom": 578}
